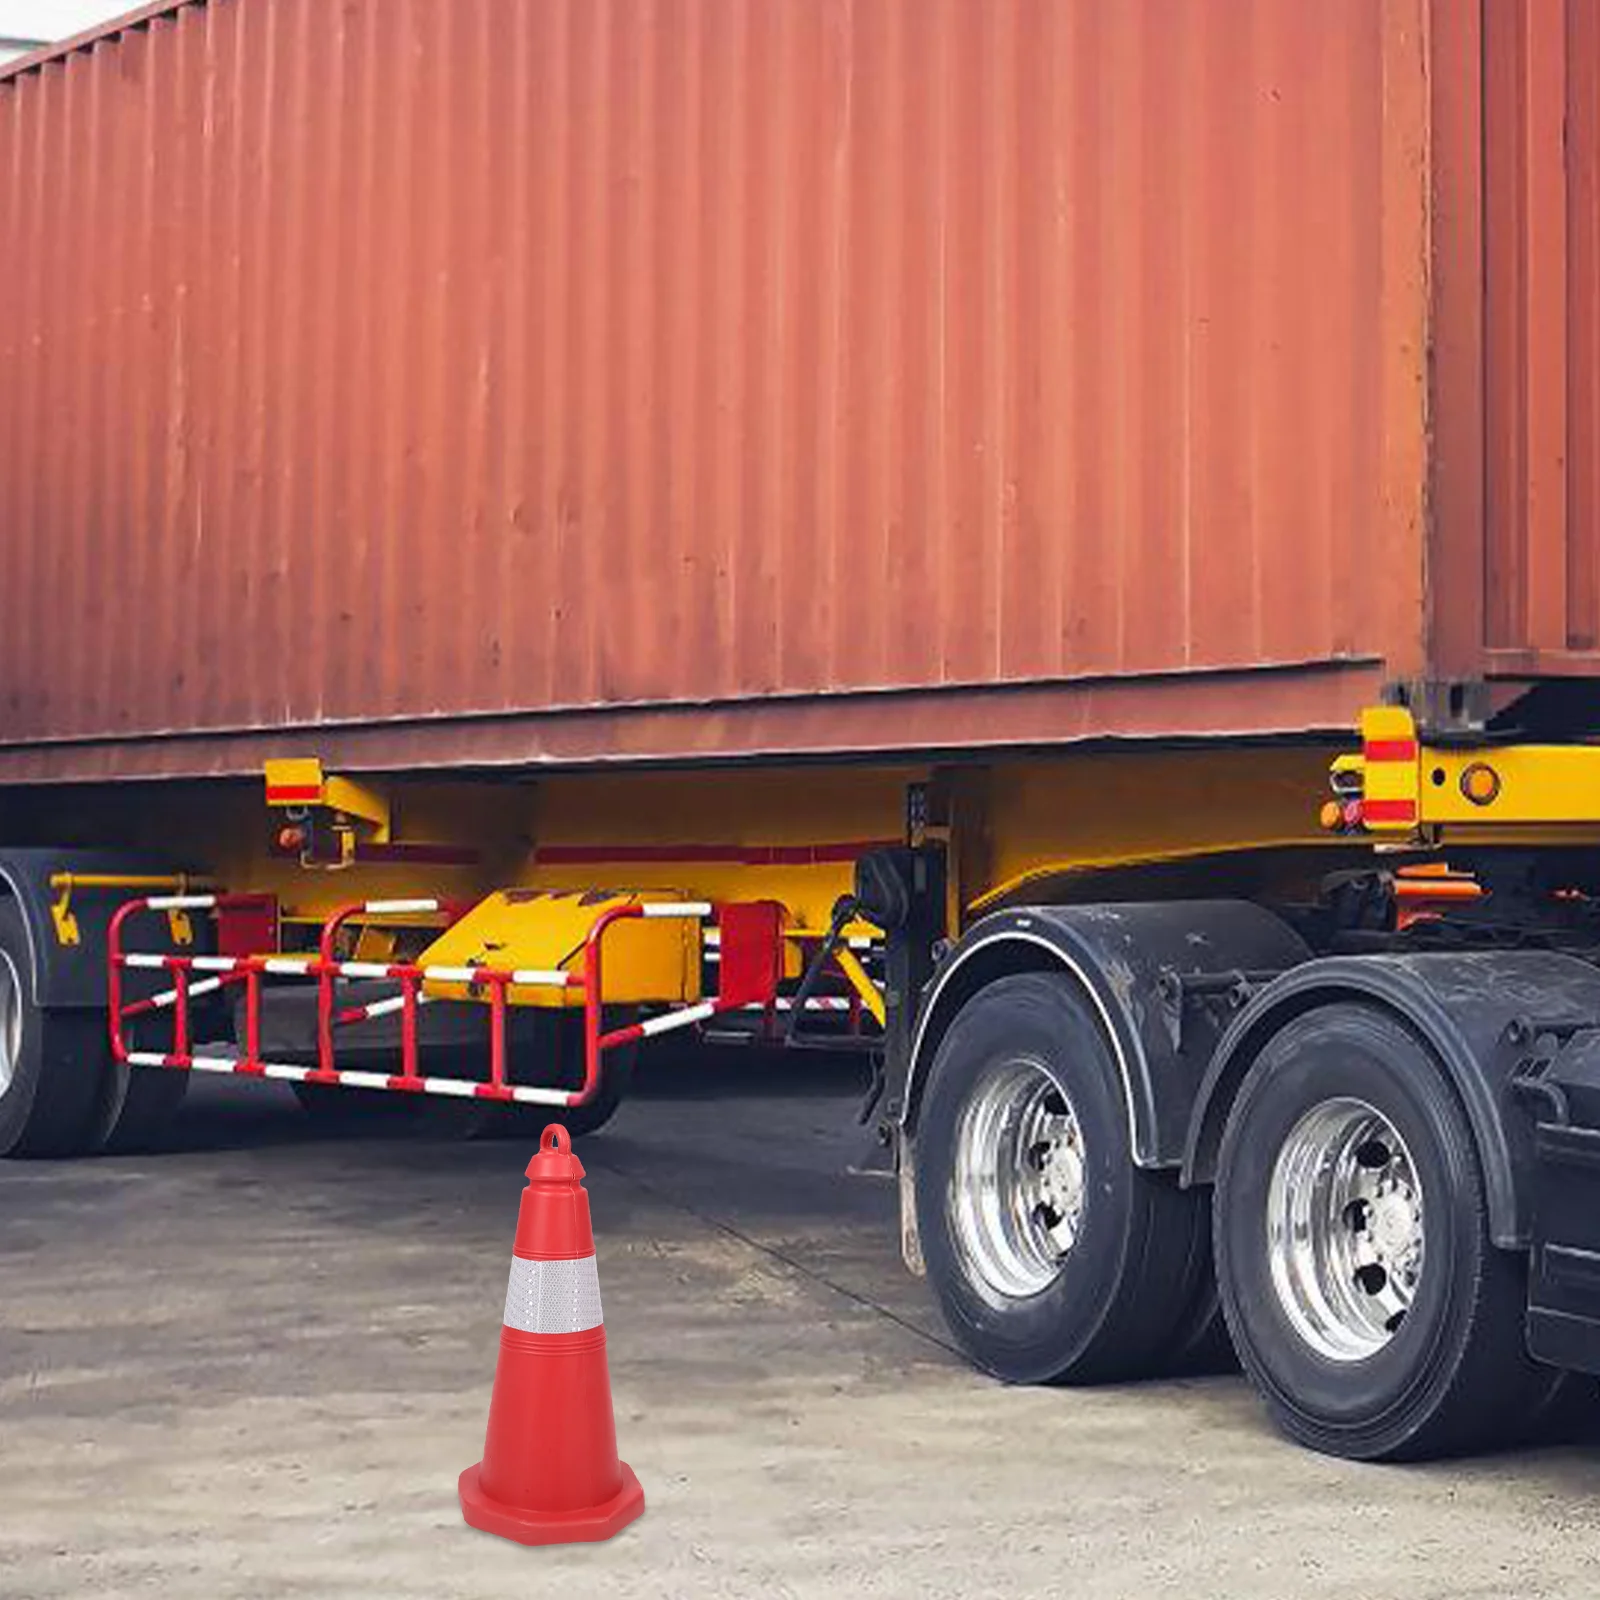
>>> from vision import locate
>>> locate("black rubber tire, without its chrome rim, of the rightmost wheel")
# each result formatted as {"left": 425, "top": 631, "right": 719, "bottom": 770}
{"left": 1213, "top": 1003, "right": 1555, "bottom": 1461}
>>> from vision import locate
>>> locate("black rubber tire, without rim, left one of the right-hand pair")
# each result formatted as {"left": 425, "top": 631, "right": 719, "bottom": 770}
{"left": 915, "top": 973, "right": 1206, "bottom": 1384}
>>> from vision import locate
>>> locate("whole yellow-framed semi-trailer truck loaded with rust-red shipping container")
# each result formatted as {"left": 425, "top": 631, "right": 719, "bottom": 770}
{"left": 0, "top": 0, "right": 1600, "bottom": 1459}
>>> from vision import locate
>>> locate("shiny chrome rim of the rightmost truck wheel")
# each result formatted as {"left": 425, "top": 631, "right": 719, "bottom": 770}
{"left": 1267, "top": 1098, "right": 1424, "bottom": 1362}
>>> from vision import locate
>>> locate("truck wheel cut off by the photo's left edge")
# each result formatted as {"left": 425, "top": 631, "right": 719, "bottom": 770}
{"left": 0, "top": 899, "right": 107, "bottom": 1155}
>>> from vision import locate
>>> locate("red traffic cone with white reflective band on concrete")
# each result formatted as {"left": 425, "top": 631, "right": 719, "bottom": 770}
{"left": 461, "top": 1123, "right": 645, "bottom": 1544}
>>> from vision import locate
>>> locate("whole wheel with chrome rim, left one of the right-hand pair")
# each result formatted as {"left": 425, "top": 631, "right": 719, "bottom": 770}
{"left": 915, "top": 973, "right": 1205, "bottom": 1382}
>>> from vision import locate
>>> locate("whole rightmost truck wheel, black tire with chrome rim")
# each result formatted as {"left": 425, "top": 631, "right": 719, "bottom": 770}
{"left": 1213, "top": 1003, "right": 1552, "bottom": 1461}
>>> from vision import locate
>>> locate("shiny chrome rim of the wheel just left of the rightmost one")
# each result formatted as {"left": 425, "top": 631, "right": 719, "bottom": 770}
{"left": 950, "top": 1058, "right": 1086, "bottom": 1304}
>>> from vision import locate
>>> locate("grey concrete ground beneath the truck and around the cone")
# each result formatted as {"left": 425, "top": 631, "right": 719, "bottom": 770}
{"left": 0, "top": 1056, "right": 1600, "bottom": 1600}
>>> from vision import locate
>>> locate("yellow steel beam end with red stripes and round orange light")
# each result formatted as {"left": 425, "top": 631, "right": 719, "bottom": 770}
{"left": 1322, "top": 706, "right": 1600, "bottom": 845}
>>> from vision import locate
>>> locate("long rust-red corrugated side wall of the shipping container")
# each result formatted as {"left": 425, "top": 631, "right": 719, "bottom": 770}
{"left": 0, "top": 0, "right": 1504, "bottom": 779}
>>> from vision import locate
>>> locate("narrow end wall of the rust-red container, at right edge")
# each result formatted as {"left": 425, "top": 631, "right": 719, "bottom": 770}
{"left": 1432, "top": 0, "right": 1600, "bottom": 677}
